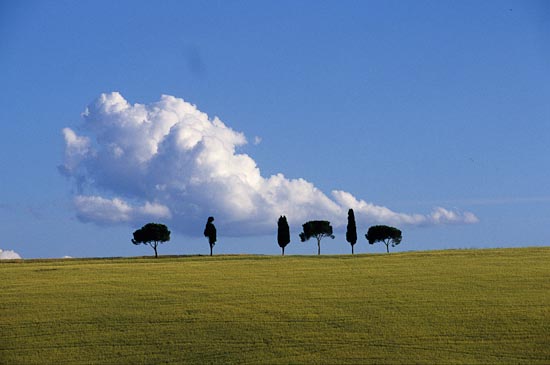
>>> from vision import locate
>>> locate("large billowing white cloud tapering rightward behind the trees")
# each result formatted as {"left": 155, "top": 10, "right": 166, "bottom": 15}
{"left": 60, "top": 92, "right": 478, "bottom": 235}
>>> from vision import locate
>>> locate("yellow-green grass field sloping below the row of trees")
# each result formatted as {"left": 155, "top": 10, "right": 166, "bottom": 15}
{"left": 0, "top": 247, "right": 550, "bottom": 364}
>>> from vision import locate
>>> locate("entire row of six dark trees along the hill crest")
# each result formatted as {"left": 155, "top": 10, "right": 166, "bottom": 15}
{"left": 132, "top": 209, "right": 402, "bottom": 257}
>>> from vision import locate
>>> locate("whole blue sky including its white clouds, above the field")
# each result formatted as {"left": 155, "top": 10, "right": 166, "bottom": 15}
{"left": 0, "top": 0, "right": 550, "bottom": 258}
